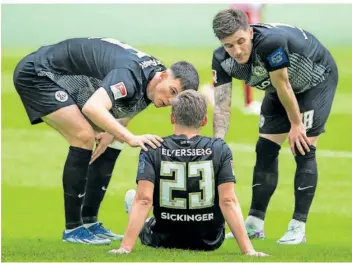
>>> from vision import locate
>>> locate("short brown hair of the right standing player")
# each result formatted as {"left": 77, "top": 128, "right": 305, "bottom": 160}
{"left": 213, "top": 8, "right": 249, "bottom": 40}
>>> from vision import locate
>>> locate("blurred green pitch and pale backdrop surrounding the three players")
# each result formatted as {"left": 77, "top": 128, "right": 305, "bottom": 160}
{"left": 1, "top": 4, "right": 352, "bottom": 261}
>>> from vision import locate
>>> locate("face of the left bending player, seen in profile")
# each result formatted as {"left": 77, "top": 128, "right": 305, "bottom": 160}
{"left": 153, "top": 72, "right": 182, "bottom": 108}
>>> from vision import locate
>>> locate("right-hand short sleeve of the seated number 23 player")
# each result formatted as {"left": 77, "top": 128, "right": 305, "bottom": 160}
{"left": 217, "top": 142, "right": 236, "bottom": 186}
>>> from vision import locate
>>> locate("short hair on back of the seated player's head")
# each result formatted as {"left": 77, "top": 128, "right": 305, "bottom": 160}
{"left": 171, "top": 89, "right": 207, "bottom": 129}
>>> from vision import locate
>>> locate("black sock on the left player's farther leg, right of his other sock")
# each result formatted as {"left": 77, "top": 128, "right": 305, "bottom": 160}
{"left": 82, "top": 147, "right": 121, "bottom": 224}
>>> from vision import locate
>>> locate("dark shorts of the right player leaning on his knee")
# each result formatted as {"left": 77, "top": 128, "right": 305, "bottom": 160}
{"left": 259, "top": 68, "right": 338, "bottom": 137}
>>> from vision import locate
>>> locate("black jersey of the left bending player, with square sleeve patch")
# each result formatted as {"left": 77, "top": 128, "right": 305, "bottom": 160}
{"left": 34, "top": 38, "right": 166, "bottom": 118}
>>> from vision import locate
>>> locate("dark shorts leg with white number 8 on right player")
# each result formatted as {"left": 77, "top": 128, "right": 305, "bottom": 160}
{"left": 296, "top": 75, "right": 337, "bottom": 137}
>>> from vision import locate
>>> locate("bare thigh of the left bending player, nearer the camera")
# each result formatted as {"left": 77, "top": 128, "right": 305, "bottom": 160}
{"left": 42, "top": 105, "right": 95, "bottom": 150}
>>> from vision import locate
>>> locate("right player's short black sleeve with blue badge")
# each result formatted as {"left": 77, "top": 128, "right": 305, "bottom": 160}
{"left": 256, "top": 34, "right": 290, "bottom": 72}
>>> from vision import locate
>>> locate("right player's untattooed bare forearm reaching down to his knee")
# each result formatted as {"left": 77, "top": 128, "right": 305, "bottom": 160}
{"left": 276, "top": 82, "right": 301, "bottom": 125}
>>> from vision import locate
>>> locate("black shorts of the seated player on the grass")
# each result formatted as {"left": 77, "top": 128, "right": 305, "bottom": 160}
{"left": 139, "top": 217, "right": 225, "bottom": 251}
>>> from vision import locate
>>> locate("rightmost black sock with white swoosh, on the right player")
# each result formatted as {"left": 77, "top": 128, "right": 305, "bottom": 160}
{"left": 293, "top": 146, "right": 318, "bottom": 222}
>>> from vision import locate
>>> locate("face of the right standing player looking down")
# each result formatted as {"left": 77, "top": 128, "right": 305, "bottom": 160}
{"left": 221, "top": 28, "right": 253, "bottom": 64}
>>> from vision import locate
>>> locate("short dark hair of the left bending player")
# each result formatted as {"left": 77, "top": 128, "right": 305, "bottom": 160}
{"left": 170, "top": 61, "right": 199, "bottom": 91}
